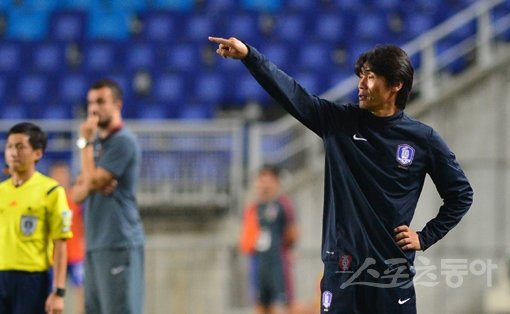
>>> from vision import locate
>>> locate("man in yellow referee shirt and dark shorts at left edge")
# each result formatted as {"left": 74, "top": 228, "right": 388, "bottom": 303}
{"left": 0, "top": 123, "right": 72, "bottom": 314}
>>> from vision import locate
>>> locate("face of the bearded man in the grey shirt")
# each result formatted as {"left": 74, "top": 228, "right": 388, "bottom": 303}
{"left": 87, "top": 87, "right": 120, "bottom": 128}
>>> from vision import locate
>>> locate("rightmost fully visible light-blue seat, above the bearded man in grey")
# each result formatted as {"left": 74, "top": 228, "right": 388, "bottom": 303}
{"left": 87, "top": 10, "right": 131, "bottom": 41}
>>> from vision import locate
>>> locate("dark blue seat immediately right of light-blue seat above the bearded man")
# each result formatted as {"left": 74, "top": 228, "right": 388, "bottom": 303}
{"left": 141, "top": 11, "right": 177, "bottom": 43}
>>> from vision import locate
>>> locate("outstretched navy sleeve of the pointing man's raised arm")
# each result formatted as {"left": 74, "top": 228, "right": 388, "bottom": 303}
{"left": 242, "top": 45, "right": 334, "bottom": 136}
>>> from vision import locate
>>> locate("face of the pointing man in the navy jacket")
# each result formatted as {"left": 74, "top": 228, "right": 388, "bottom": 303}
{"left": 358, "top": 66, "right": 397, "bottom": 112}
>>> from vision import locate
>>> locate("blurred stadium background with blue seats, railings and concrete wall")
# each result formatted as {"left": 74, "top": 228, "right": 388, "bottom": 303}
{"left": 0, "top": 0, "right": 510, "bottom": 313}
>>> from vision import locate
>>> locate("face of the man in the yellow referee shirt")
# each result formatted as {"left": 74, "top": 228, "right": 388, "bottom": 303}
{"left": 5, "top": 134, "right": 42, "bottom": 174}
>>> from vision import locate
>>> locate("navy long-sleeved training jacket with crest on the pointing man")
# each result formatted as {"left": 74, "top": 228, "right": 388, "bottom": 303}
{"left": 242, "top": 46, "right": 473, "bottom": 273}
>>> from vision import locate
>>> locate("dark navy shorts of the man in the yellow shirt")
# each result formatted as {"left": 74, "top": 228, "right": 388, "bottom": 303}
{"left": 0, "top": 271, "right": 51, "bottom": 314}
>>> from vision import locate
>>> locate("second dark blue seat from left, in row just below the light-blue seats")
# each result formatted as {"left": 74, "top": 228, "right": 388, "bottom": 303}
{"left": 31, "top": 41, "right": 65, "bottom": 72}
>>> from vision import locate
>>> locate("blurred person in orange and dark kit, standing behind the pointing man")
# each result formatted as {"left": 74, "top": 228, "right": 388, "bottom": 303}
{"left": 241, "top": 166, "right": 298, "bottom": 314}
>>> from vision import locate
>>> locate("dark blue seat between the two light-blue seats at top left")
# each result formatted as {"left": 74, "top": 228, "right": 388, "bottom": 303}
{"left": 49, "top": 10, "right": 85, "bottom": 42}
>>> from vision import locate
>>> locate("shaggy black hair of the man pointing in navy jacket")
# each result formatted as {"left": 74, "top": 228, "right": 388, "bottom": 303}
{"left": 354, "top": 45, "right": 414, "bottom": 110}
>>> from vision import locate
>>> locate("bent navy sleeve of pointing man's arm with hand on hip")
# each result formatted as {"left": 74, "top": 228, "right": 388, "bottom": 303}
{"left": 418, "top": 131, "right": 473, "bottom": 250}
